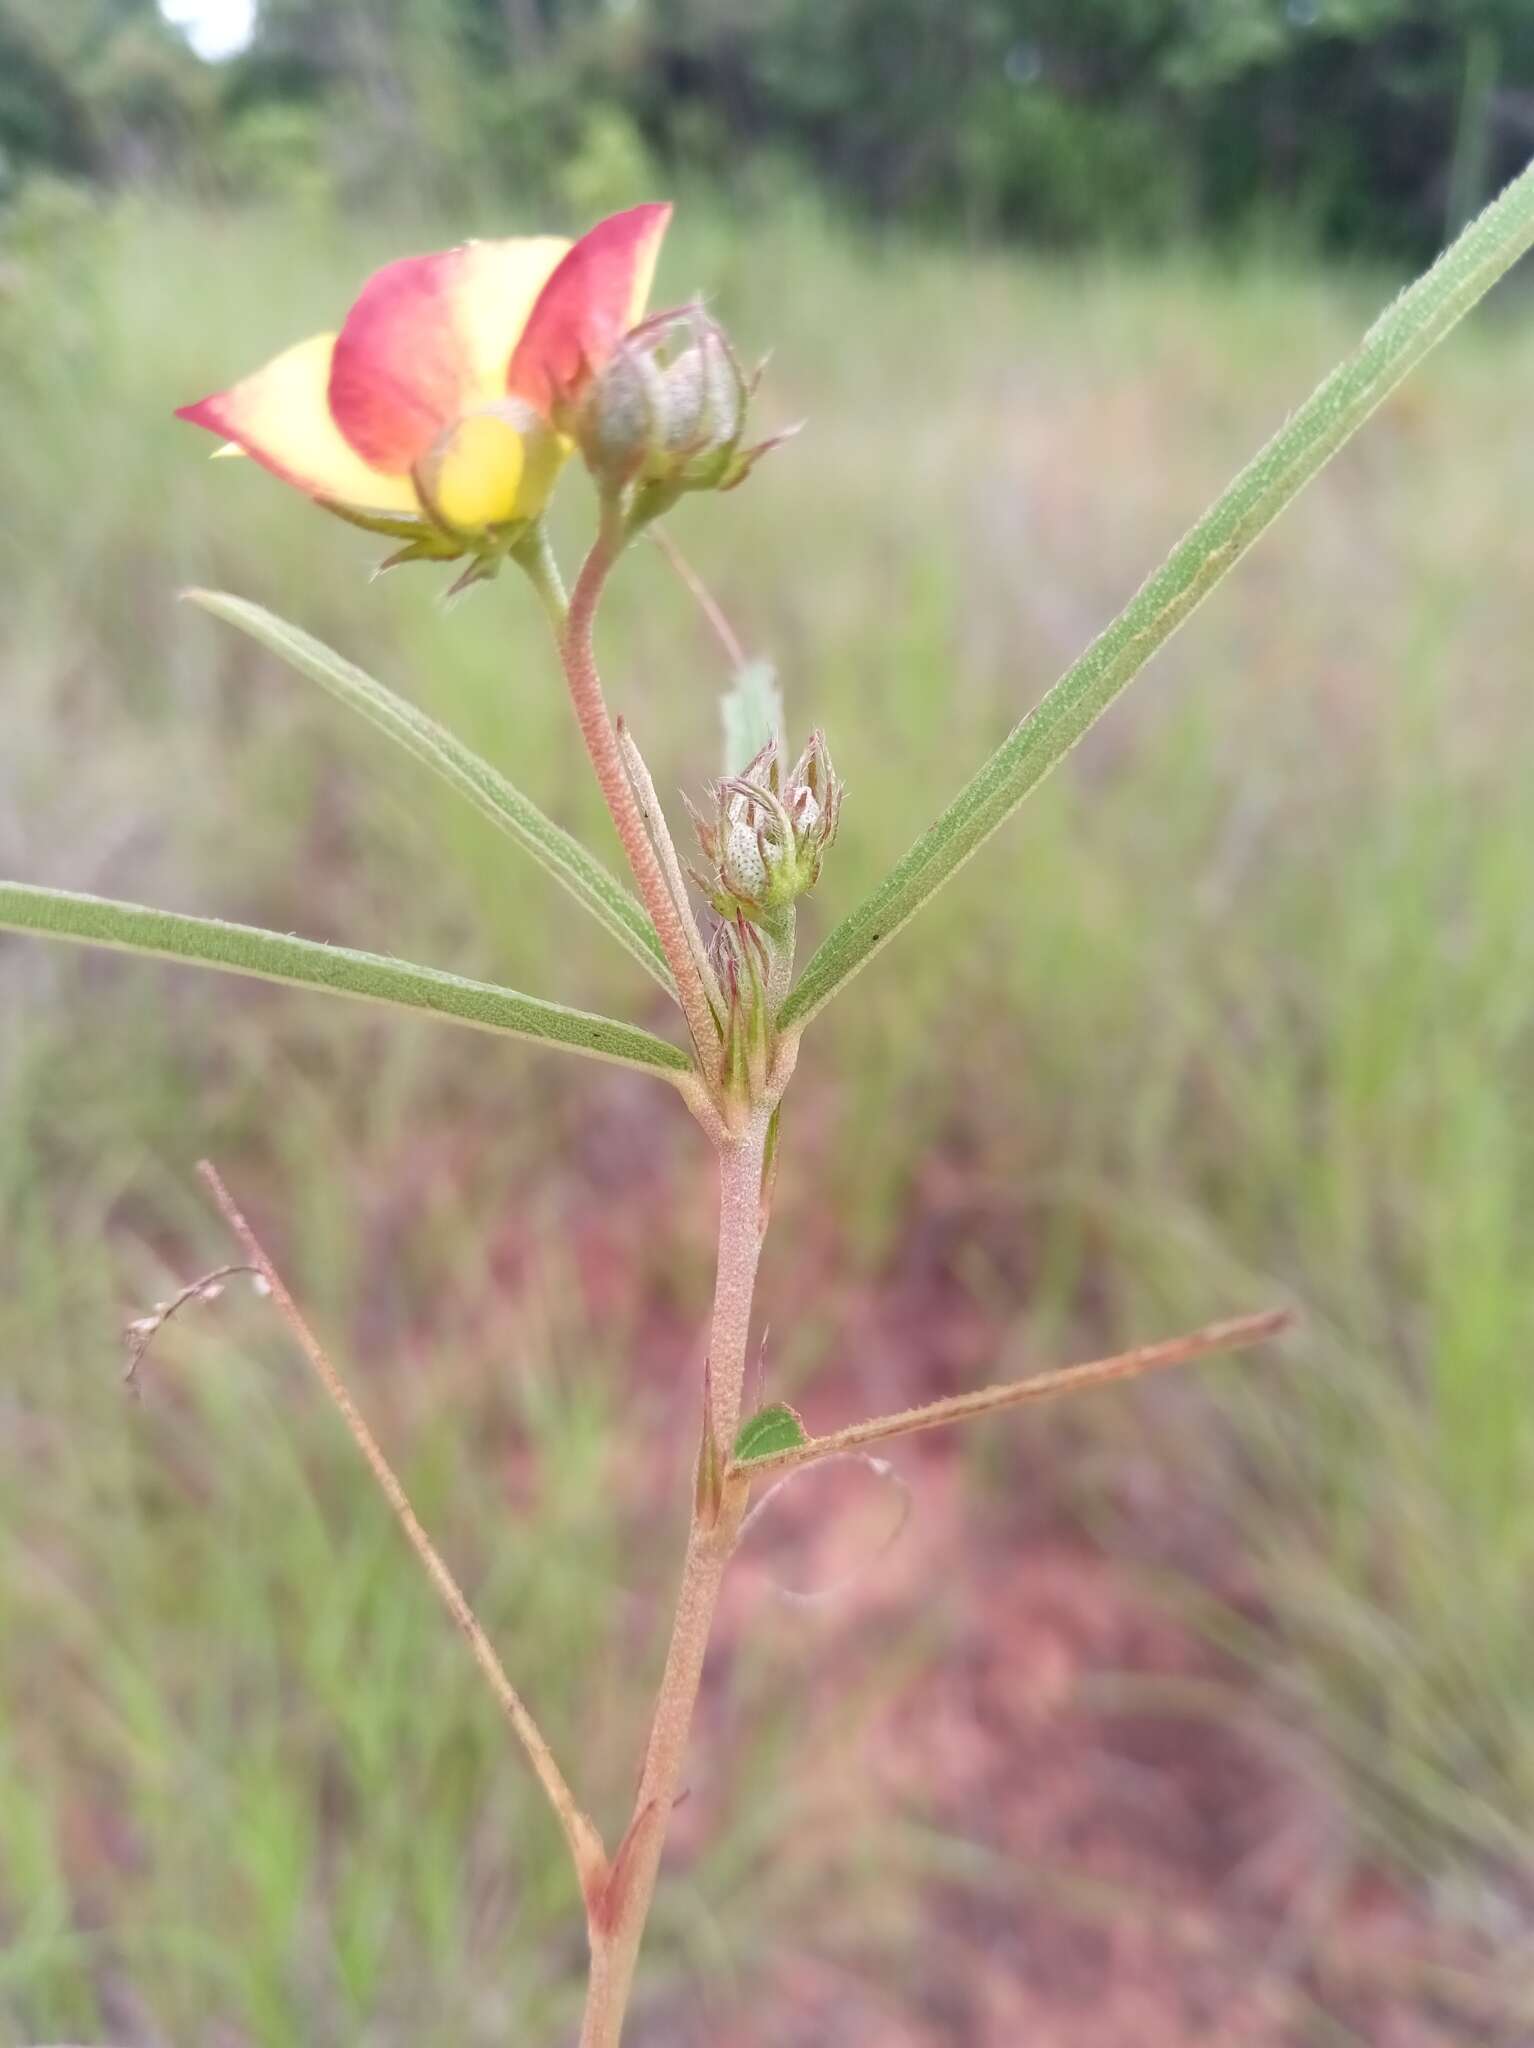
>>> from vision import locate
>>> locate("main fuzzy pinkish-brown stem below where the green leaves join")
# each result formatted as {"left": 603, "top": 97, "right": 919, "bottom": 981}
{"left": 580, "top": 1108, "right": 770, "bottom": 2048}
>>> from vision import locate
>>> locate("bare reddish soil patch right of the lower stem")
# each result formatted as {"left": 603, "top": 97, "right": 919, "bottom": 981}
{"left": 557, "top": 1155, "right": 1534, "bottom": 2048}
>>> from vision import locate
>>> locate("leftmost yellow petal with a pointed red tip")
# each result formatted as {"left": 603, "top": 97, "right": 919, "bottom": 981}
{"left": 176, "top": 334, "right": 420, "bottom": 514}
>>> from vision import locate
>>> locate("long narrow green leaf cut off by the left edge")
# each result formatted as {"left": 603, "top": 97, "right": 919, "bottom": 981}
{"left": 0, "top": 883, "right": 692, "bottom": 1075}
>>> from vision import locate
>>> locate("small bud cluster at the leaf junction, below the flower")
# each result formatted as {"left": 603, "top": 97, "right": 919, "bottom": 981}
{"left": 690, "top": 733, "right": 842, "bottom": 924}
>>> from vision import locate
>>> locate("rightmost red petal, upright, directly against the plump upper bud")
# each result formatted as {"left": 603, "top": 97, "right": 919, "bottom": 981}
{"left": 506, "top": 205, "right": 672, "bottom": 420}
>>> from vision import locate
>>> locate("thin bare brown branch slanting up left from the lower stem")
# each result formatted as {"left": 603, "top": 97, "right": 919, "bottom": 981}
{"left": 197, "top": 1159, "right": 608, "bottom": 1892}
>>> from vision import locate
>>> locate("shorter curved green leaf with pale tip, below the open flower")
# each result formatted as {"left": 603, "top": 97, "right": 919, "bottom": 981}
{"left": 182, "top": 590, "right": 672, "bottom": 993}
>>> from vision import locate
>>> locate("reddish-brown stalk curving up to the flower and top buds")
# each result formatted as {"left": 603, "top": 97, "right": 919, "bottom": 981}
{"left": 559, "top": 510, "right": 719, "bottom": 1079}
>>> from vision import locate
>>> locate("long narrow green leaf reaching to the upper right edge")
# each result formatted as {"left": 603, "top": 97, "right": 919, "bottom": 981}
{"left": 778, "top": 166, "right": 1534, "bottom": 1028}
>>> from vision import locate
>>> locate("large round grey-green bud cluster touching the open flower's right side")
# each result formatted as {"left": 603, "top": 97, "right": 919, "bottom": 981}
{"left": 576, "top": 305, "right": 784, "bottom": 498}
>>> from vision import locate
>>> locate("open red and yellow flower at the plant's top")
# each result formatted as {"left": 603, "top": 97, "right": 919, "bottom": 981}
{"left": 178, "top": 205, "right": 672, "bottom": 561}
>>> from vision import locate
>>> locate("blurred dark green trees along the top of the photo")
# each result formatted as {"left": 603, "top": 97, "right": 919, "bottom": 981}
{"left": 0, "top": 0, "right": 1534, "bottom": 258}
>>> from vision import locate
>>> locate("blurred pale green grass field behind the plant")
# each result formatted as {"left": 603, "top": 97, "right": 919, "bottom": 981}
{"left": 0, "top": 188, "right": 1534, "bottom": 2048}
